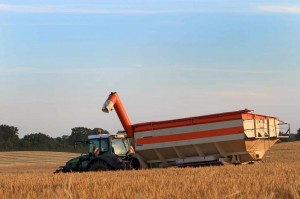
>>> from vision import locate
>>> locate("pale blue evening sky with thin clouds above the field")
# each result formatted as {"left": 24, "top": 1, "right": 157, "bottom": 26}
{"left": 0, "top": 0, "right": 300, "bottom": 137}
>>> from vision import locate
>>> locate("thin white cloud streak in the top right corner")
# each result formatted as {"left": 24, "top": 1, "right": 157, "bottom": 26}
{"left": 257, "top": 5, "right": 300, "bottom": 14}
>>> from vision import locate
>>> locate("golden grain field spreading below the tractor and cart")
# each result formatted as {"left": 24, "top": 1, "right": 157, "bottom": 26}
{"left": 0, "top": 142, "right": 300, "bottom": 198}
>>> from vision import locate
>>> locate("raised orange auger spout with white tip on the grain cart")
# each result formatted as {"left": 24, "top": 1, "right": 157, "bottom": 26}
{"left": 102, "top": 92, "right": 133, "bottom": 138}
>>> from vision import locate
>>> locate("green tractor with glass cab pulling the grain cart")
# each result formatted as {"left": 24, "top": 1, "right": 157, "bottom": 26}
{"left": 54, "top": 133, "right": 140, "bottom": 173}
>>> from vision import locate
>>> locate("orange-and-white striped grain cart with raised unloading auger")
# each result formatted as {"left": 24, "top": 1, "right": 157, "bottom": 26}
{"left": 102, "top": 92, "right": 289, "bottom": 168}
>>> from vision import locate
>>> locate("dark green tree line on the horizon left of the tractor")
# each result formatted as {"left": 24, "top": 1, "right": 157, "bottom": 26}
{"left": 0, "top": 125, "right": 108, "bottom": 152}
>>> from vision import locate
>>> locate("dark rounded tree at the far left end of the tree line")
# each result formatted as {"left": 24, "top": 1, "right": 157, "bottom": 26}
{"left": 0, "top": 124, "right": 19, "bottom": 151}
